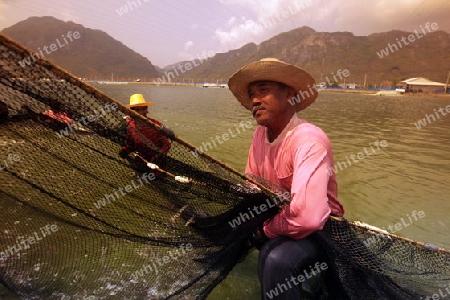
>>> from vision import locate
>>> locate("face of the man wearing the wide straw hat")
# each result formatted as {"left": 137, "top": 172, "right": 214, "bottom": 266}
{"left": 248, "top": 81, "right": 295, "bottom": 126}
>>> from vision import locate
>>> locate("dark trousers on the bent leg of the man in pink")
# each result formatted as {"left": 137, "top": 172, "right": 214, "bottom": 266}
{"left": 258, "top": 234, "right": 327, "bottom": 300}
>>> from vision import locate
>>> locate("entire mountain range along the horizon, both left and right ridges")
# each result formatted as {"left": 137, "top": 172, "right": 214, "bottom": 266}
{"left": 2, "top": 17, "right": 450, "bottom": 85}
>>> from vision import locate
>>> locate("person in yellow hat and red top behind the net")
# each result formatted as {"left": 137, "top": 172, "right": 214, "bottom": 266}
{"left": 120, "top": 94, "right": 175, "bottom": 165}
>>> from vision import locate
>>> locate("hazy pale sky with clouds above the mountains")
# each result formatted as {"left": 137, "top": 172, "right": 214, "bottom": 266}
{"left": 0, "top": 0, "right": 450, "bottom": 67}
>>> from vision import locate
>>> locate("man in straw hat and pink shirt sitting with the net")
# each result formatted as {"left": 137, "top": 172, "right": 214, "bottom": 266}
{"left": 228, "top": 58, "right": 344, "bottom": 299}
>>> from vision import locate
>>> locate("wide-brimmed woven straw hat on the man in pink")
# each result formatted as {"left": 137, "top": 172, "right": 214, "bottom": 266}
{"left": 228, "top": 58, "right": 318, "bottom": 111}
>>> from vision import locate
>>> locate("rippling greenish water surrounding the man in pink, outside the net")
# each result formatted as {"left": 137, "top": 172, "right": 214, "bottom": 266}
{"left": 97, "top": 85, "right": 450, "bottom": 299}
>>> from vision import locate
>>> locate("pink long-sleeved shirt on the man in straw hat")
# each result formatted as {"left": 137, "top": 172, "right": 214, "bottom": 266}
{"left": 246, "top": 114, "right": 344, "bottom": 239}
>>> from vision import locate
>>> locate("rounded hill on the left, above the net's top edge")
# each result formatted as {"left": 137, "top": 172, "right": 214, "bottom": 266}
{"left": 2, "top": 17, "right": 159, "bottom": 79}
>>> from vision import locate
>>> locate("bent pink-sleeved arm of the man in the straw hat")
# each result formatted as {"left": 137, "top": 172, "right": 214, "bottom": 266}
{"left": 264, "top": 141, "right": 331, "bottom": 239}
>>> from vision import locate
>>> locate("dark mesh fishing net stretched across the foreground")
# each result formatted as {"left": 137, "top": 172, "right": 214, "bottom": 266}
{"left": 0, "top": 31, "right": 450, "bottom": 299}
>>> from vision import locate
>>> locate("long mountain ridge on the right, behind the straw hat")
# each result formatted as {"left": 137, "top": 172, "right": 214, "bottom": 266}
{"left": 176, "top": 27, "right": 450, "bottom": 85}
